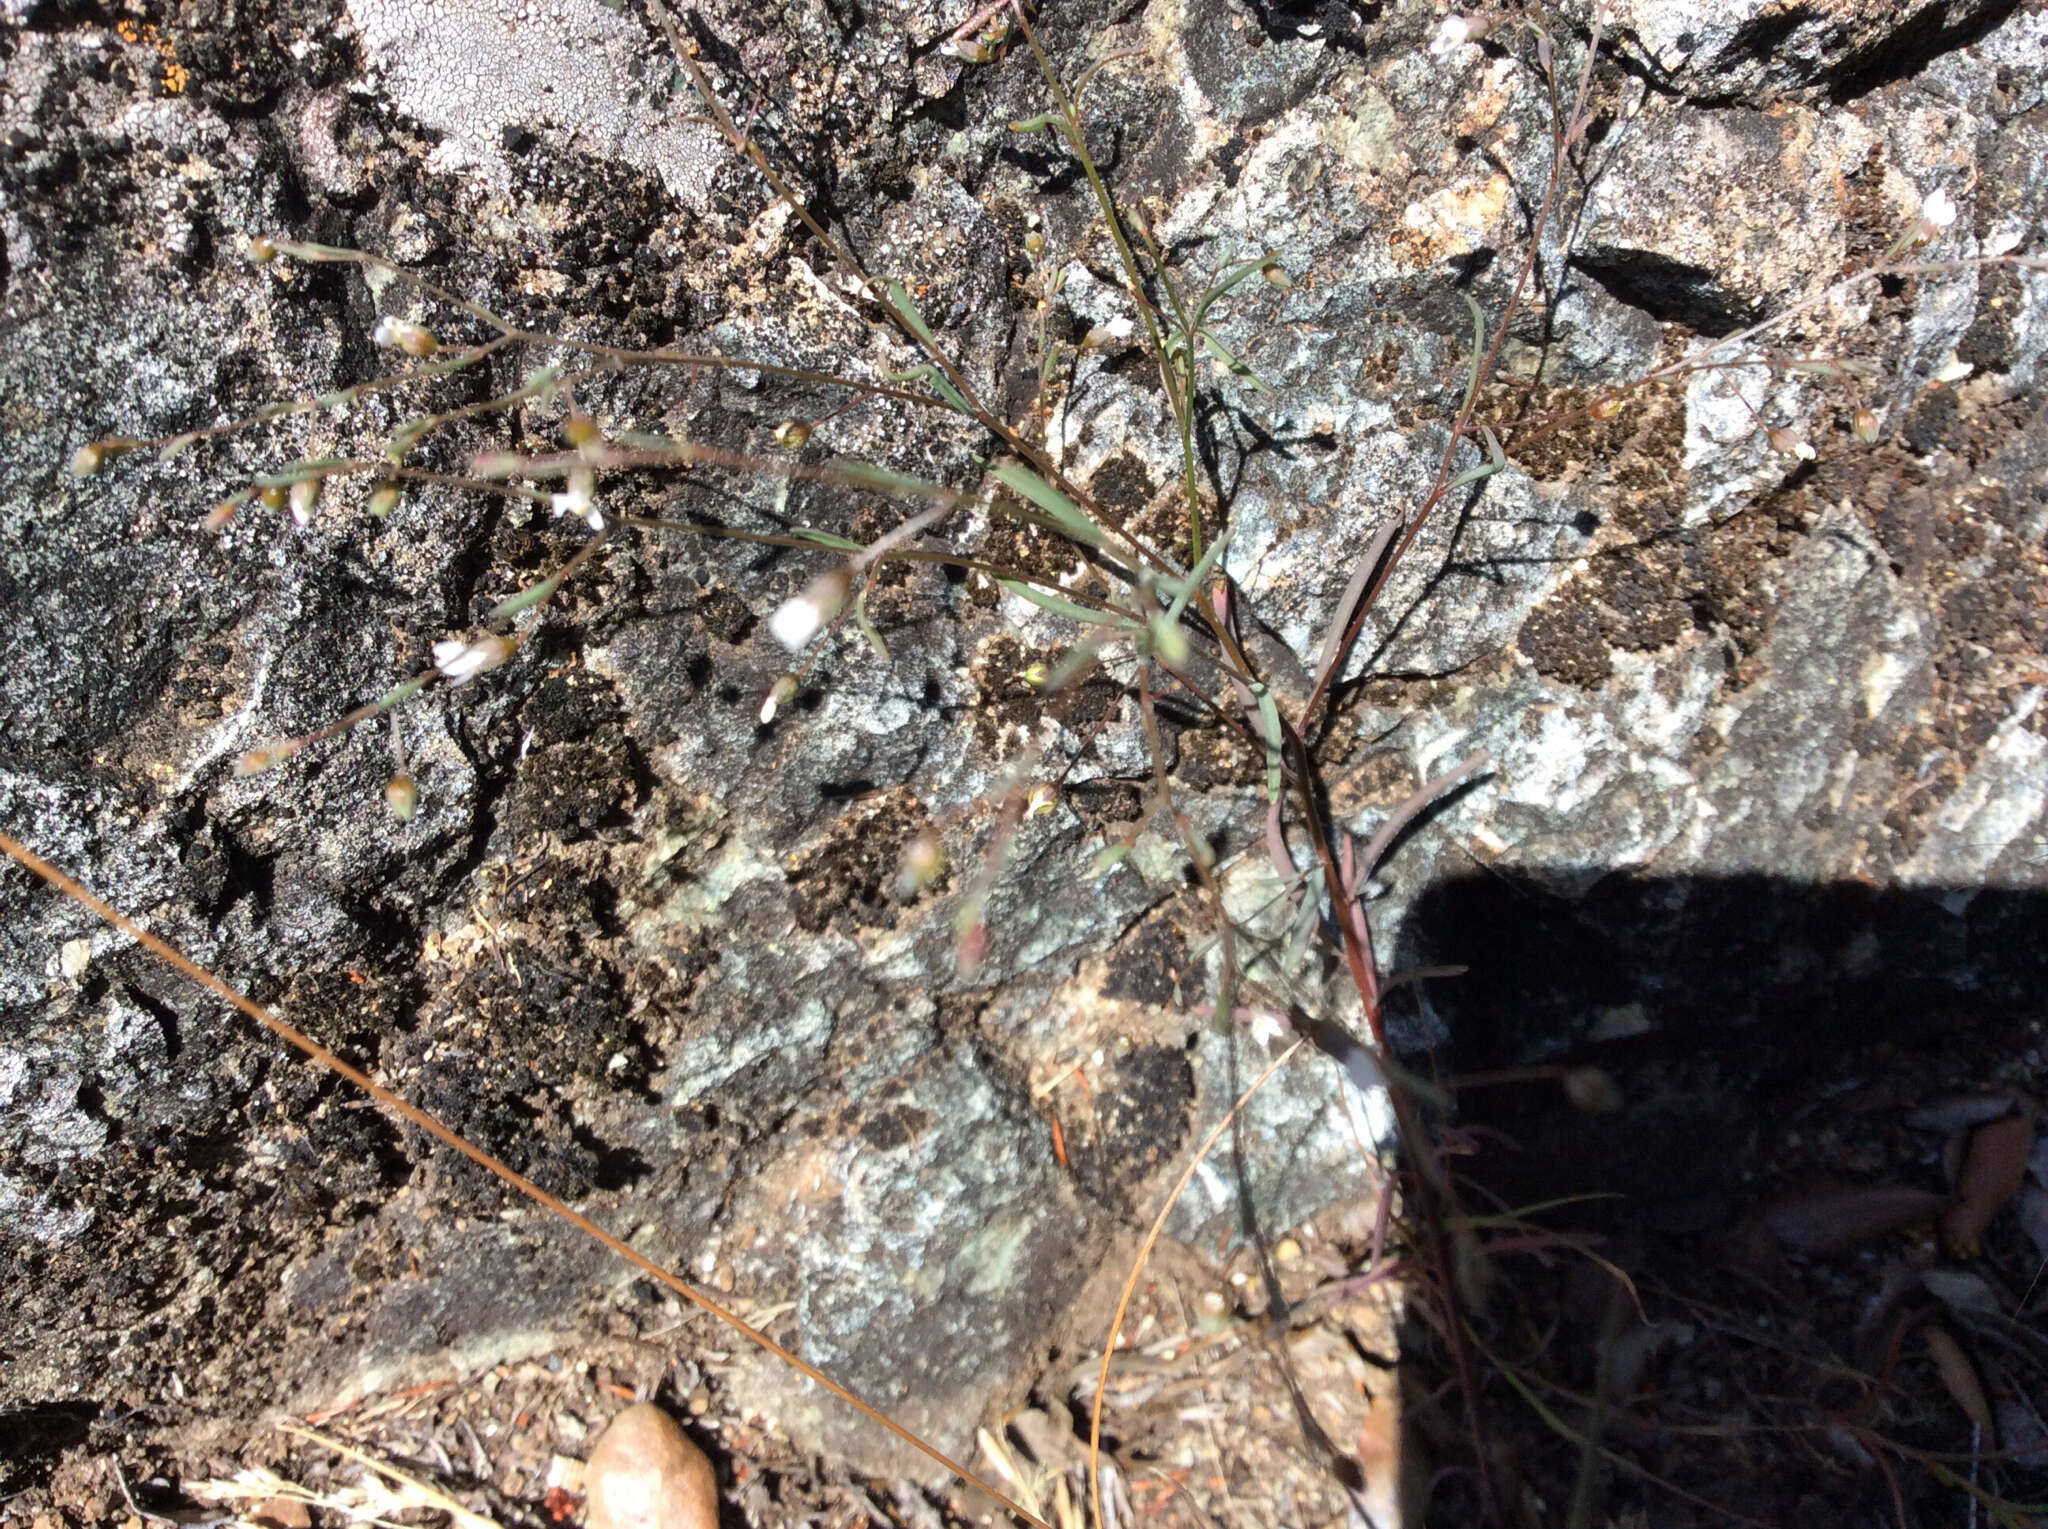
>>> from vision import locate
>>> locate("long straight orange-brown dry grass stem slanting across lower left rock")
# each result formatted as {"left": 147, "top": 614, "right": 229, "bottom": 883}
{"left": 0, "top": 833, "right": 1048, "bottom": 1529}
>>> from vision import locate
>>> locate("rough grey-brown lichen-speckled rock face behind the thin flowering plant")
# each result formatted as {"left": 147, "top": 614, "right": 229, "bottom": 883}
{"left": 0, "top": 0, "right": 2048, "bottom": 1506}
